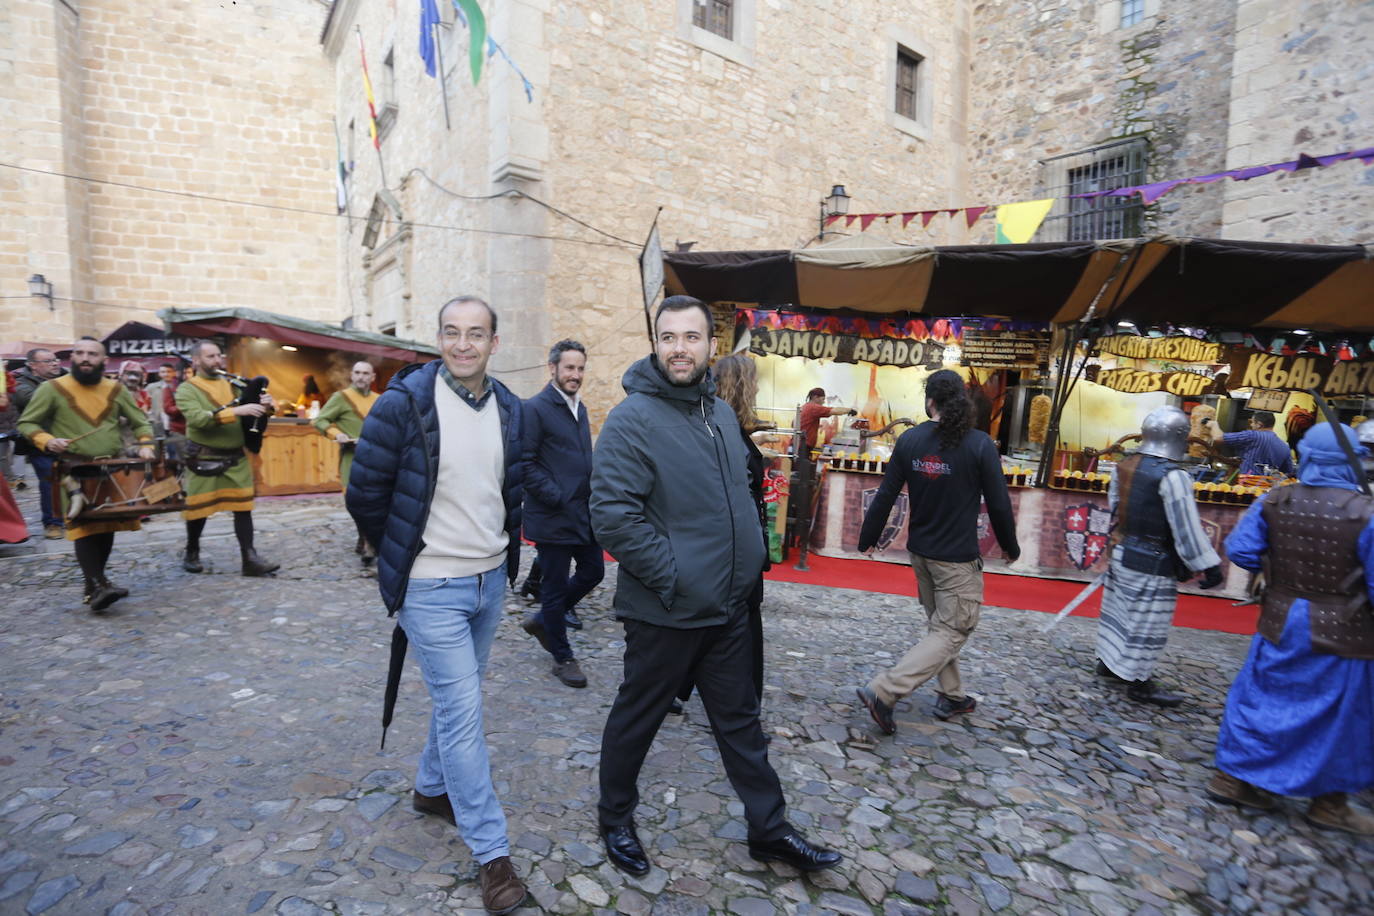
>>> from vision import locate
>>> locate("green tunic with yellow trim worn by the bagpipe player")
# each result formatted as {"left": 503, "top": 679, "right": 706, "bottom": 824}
{"left": 176, "top": 375, "right": 256, "bottom": 522}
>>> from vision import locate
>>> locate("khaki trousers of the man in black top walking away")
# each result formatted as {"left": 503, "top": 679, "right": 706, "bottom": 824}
{"left": 868, "top": 553, "right": 982, "bottom": 706}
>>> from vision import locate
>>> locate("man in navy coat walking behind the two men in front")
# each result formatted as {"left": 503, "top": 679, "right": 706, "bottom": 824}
{"left": 523, "top": 341, "right": 606, "bottom": 687}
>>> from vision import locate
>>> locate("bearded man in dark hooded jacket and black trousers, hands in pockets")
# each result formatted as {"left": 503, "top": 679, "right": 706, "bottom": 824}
{"left": 591, "top": 295, "right": 841, "bottom": 875}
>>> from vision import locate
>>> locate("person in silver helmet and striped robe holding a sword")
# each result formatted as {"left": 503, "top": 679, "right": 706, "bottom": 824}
{"left": 1098, "top": 407, "right": 1221, "bottom": 706}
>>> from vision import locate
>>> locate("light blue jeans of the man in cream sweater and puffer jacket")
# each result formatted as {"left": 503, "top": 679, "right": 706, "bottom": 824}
{"left": 397, "top": 563, "right": 510, "bottom": 865}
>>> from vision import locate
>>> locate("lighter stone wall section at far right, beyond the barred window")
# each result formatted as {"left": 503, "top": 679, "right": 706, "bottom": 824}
{"left": 1224, "top": 0, "right": 1374, "bottom": 244}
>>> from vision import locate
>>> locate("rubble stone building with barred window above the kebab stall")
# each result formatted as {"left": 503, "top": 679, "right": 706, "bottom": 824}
{"left": 969, "top": 0, "right": 1374, "bottom": 244}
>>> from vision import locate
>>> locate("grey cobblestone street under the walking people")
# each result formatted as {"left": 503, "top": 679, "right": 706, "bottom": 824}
{"left": 0, "top": 488, "right": 1374, "bottom": 916}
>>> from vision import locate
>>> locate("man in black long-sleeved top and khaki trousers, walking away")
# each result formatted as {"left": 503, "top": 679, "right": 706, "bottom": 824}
{"left": 859, "top": 369, "right": 1021, "bottom": 735}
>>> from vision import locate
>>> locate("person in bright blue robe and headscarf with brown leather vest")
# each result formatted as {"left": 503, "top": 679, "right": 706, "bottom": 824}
{"left": 1206, "top": 423, "right": 1374, "bottom": 835}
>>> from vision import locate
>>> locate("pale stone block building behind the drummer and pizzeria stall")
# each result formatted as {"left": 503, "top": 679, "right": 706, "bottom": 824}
{"left": 0, "top": 0, "right": 335, "bottom": 343}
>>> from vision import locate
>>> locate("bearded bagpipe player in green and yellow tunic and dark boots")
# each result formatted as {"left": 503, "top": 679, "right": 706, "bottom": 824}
{"left": 176, "top": 341, "right": 282, "bottom": 575}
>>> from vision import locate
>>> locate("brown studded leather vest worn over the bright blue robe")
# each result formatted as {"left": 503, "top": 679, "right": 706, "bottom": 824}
{"left": 1259, "top": 483, "right": 1374, "bottom": 659}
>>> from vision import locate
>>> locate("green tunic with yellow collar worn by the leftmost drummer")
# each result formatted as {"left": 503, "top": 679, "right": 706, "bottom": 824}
{"left": 19, "top": 375, "right": 153, "bottom": 541}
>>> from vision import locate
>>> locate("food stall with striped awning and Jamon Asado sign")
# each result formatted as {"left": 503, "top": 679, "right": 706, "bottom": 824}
{"left": 665, "top": 236, "right": 1374, "bottom": 596}
